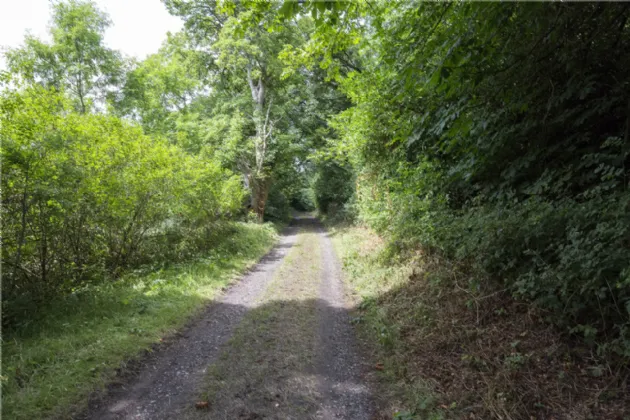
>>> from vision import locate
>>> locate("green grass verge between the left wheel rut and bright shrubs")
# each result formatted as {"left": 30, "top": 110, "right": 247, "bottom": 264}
{"left": 2, "top": 223, "right": 277, "bottom": 420}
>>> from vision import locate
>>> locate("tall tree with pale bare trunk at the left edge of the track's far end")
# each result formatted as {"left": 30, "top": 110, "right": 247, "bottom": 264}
{"left": 165, "top": 0, "right": 308, "bottom": 221}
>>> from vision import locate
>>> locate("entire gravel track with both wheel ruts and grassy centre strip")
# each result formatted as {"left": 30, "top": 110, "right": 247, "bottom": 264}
{"left": 84, "top": 217, "right": 371, "bottom": 420}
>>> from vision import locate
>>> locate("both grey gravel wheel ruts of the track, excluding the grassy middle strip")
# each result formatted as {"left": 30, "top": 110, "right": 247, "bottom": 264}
{"left": 80, "top": 217, "right": 373, "bottom": 420}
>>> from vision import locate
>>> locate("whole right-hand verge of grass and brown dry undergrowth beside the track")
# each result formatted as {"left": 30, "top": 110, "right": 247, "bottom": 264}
{"left": 331, "top": 227, "right": 630, "bottom": 420}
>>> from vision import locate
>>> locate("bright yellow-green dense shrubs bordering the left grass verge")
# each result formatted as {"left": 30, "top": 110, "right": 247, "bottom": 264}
{"left": 0, "top": 83, "right": 244, "bottom": 323}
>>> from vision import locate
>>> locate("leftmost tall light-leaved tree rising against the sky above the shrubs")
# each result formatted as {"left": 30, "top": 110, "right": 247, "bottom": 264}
{"left": 7, "top": 0, "right": 122, "bottom": 113}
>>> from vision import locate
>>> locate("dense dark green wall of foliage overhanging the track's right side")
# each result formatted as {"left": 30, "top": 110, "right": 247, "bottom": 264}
{"left": 287, "top": 2, "right": 630, "bottom": 357}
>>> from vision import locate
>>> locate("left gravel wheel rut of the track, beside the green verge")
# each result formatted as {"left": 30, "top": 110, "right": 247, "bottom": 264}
{"left": 85, "top": 227, "right": 298, "bottom": 420}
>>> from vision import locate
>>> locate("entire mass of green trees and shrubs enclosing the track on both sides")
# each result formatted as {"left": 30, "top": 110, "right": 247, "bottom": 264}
{"left": 0, "top": 0, "right": 630, "bottom": 364}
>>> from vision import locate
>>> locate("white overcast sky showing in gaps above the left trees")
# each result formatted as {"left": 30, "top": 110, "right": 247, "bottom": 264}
{"left": 0, "top": 0, "right": 183, "bottom": 69}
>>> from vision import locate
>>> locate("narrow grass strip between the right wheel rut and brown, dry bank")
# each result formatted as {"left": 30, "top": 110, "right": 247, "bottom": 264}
{"left": 329, "top": 226, "right": 444, "bottom": 420}
